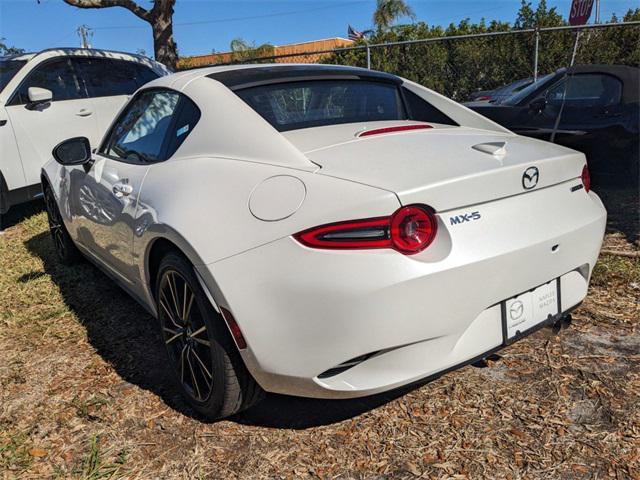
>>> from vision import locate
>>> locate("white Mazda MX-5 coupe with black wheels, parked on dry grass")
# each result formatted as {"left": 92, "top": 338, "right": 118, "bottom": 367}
{"left": 42, "top": 65, "right": 606, "bottom": 418}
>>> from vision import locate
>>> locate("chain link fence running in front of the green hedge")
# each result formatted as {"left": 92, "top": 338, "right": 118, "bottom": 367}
{"left": 181, "top": 21, "right": 640, "bottom": 101}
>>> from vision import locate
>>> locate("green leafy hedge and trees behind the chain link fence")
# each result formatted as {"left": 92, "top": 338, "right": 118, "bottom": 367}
{"left": 323, "top": 0, "right": 640, "bottom": 100}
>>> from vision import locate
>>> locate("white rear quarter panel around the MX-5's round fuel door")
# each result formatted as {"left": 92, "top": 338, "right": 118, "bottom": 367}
{"left": 133, "top": 157, "right": 400, "bottom": 308}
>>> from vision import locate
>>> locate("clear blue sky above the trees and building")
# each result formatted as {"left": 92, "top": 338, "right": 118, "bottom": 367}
{"left": 0, "top": 0, "right": 638, "bottom": 55}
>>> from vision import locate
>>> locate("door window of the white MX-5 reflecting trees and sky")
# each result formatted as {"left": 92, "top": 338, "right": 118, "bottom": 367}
{"left": 101, "top": 90, "right": 180, "bottom": 163}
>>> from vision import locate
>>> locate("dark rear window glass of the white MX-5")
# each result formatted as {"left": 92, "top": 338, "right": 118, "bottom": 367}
{"left": 236, "top": 80, "right": 407, "bottom": 132}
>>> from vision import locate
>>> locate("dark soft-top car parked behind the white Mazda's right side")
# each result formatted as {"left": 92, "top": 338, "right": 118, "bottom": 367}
{"left": 470, "top": 65, "right": 640, "bottom": 188}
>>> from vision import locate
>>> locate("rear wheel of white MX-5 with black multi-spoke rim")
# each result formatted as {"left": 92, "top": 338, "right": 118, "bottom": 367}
{"left": 155, "top": 252, "right": 264, "bottom": 420}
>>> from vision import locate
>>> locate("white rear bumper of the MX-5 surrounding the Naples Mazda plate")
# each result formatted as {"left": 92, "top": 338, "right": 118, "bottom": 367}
{"left": 199, "top": 186, "right": 606, "bottom": 398}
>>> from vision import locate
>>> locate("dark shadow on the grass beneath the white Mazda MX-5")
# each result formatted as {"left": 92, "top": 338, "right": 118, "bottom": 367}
{"left": 19, "top": 233, "right": 416, "bottom": 429}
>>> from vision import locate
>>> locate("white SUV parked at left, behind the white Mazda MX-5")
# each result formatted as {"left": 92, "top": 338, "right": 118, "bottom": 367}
{"left": 0, "top": 48, "right": 169, "bottom": 220}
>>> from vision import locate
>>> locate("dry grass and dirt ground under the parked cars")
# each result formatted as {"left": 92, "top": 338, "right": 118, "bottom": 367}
{"left": 0, "top": 188, "right": 640, "bottom": 480}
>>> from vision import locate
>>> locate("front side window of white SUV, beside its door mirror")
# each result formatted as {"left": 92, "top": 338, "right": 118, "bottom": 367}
{"left": 10, "top": 58, "right": 86, "bottom": 105}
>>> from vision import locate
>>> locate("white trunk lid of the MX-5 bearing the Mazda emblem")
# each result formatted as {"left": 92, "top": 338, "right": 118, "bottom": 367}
{"left": 284, "top": 122, "right": 584, "bottom": 211}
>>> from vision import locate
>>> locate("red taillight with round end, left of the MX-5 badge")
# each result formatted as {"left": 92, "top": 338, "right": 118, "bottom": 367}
{"left": 294, "top": 205, "right": 438, "bottom": 255}
